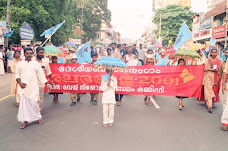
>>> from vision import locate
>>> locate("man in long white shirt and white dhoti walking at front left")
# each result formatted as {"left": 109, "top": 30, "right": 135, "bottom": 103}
{"left": 15, "top": 48, "right": 47, "bottom": 129}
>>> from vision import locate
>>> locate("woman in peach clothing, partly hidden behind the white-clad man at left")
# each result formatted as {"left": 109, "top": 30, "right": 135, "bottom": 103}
{"left": 10, "top": 50, "right": 21, "bottom": 107}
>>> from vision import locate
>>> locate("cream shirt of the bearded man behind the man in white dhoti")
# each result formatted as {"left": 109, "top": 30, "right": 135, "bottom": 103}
{"left": 37, "top": 58, "right": 52, "bottom": 88}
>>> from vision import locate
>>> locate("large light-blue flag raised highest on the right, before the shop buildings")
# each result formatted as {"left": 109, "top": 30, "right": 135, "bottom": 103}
{"left": 174, "top": 23, "right": 192, "bottom": 51}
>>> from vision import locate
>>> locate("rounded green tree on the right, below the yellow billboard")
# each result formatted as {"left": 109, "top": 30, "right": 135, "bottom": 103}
{"left": 153, "top": 5, "right": 193, "bottom": 45}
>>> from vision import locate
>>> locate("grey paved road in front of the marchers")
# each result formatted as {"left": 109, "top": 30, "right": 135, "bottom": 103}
{"left": 0, "top": 75, "right": 228, "bottom": 151}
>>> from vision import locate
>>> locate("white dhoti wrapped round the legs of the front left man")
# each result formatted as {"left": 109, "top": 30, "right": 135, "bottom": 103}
{"left": 17, "top": 95, "right": 42, "bottom": 123}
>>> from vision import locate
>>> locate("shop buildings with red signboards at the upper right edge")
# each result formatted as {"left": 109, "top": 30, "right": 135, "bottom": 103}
{"left": 192, "top": 0, "right": 228, "bottom": 52}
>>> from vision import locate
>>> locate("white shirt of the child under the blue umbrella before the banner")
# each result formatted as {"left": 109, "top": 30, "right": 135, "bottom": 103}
{"left": 101, "top": 76, "right": 117, "bottom": 104}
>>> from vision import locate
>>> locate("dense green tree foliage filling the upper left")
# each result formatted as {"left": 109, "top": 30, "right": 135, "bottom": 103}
{"left": 0, "top": 0, "right": 111, "bottom": 44}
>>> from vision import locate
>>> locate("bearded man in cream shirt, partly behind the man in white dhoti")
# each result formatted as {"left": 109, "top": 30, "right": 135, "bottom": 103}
{"left": 36, "top": 47, "right": 53, "bottom": 112}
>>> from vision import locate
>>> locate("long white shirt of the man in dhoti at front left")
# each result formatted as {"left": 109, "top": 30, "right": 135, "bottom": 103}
{"left": 15, "top": 60, "right": 47, "bottom": 102}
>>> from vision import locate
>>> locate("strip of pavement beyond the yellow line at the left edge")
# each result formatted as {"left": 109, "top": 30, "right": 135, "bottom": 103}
{"left": 0, "top": 73, "right": 12, "bottom": 99}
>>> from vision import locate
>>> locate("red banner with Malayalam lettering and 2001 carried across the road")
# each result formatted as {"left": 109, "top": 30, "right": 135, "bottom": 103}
{"left": 46, "top": 64, "right": 204, "bottom": 97}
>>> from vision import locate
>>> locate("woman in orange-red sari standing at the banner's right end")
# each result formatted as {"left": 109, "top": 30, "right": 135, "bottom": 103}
{"left": 203, "top": 49, "right": 221, "bottom": 113}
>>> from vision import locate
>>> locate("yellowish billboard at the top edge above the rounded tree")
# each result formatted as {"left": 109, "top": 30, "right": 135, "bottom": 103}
{"left": 152, "top": 0, "right": 191, "bottom": 11}
